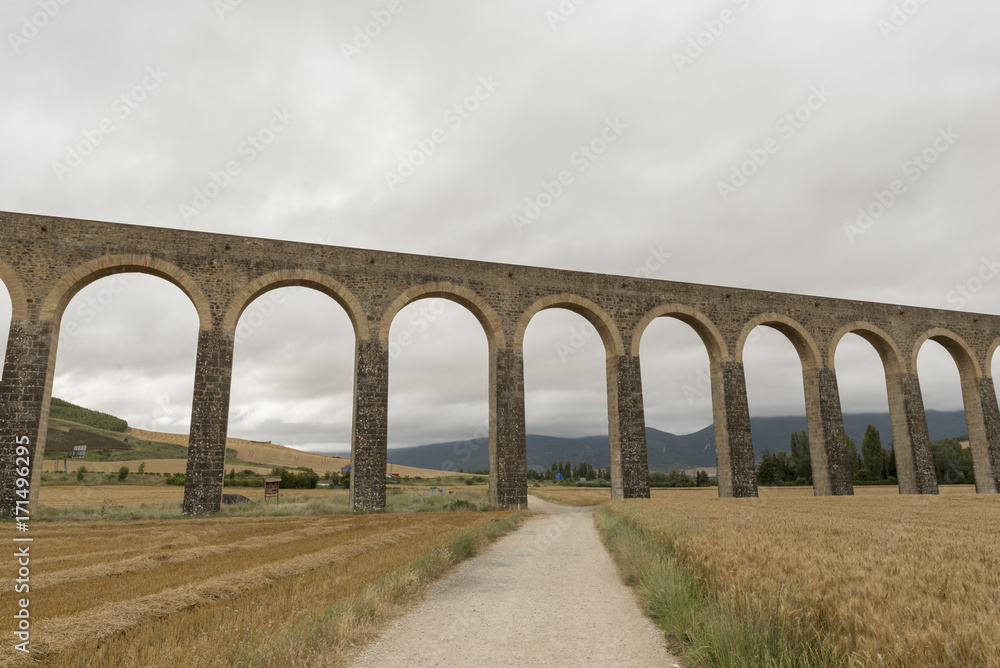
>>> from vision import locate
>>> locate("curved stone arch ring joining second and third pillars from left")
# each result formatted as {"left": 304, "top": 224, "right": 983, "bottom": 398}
{"left": 222, "top": 269, "right": 371, "bottom": 340}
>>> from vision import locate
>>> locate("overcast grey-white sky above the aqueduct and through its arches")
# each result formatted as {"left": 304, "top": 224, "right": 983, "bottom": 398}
{"left": 0, "top": 0, "right": 1000, "bottom": 450}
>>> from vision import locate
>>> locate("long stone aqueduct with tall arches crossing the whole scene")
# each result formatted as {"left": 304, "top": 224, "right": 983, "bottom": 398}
{"left": 0, "top": 213, "right": 1000, "bottom": 517}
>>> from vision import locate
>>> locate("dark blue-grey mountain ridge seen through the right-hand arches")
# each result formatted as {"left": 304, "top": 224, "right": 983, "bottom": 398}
{"left": 366, "top": 411, "right": 967, "bottom": 471}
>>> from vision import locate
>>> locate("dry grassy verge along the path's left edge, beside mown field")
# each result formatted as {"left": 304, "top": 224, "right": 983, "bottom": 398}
{"left": 240, "top": 512, "right": 527, "bottom": 668}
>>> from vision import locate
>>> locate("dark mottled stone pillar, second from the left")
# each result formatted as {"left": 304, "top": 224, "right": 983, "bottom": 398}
{"left": 184, "top": 329, "right": 235, "bottom": 515}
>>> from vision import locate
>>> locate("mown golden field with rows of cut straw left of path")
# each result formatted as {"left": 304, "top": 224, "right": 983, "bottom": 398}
{"left": 0, "top": 512, "right": 509, "bottom": 668}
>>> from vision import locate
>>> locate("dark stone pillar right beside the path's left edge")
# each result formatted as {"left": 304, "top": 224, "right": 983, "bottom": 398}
{"left": 489, "top": 348, "right": 528, "bottom": 510}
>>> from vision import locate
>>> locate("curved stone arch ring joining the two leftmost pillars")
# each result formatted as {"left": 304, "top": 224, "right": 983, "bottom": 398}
{"left": 40, "top": 255, "right": 212, "bottom": 330}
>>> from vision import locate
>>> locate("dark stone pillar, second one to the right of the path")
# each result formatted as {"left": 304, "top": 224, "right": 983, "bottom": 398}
{"left": 712, "top": 362, "right": 757, "bottom": 499}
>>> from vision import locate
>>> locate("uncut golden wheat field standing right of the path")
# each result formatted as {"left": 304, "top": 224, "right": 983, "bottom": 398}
{"left": 610, "top": 486, "right": 1000, "bottom": 667}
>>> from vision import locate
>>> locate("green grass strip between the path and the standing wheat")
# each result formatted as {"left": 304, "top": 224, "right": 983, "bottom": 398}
{"left": 594, "top": 506, "right": 860, "bottom": 668}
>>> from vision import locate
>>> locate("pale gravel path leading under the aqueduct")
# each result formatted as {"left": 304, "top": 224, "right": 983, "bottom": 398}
{"left": 353, "top": 497, "right": 676, "bottom": 668}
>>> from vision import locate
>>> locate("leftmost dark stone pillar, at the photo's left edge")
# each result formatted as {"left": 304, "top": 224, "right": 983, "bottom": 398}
{"left": 0, "top": 320, "right": 58, "bottom": 519}
